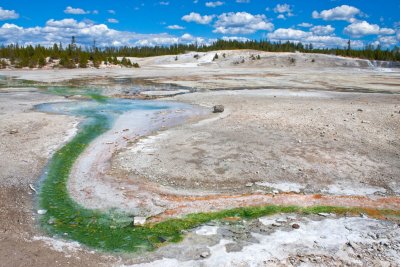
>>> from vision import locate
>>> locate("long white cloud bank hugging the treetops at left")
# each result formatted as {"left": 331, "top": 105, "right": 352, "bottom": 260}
{"left": 0, "top": 19, "right": 210, "bottom": 47}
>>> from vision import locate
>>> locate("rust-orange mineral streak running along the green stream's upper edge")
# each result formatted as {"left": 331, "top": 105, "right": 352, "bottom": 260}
{"left": 151, "top": 193, "right": 400, "bottom": 222}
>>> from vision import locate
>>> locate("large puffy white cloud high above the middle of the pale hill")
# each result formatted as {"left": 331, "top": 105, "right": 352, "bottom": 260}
{"left": 213, "top": 12, "right": 274, "bottom": 34}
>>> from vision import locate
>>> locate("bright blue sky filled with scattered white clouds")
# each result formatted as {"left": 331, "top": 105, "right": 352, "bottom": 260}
{"left": 0, "top": 0, "right": 400, "bottom": 48}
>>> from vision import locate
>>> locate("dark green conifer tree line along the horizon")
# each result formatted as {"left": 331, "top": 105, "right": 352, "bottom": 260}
{"left": 0, "top": 37, "right": 400, "bottom": 68}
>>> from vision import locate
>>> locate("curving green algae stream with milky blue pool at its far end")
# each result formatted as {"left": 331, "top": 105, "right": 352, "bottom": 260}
{"left": 37, "top": 93, "right": 398, "bottom": 252}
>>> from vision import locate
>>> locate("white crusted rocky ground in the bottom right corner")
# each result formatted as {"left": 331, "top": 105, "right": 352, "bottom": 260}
{"left": 123, "top": 215, "right": 400, "bottom": 267}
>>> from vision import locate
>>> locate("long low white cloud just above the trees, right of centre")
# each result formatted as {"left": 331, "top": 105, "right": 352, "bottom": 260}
{"left": 267, "top": 28, "right": 364, "bottom": 48}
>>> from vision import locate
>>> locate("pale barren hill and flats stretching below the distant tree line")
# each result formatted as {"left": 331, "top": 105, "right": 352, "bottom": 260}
{"left": 0, "top": 50, "right": 400, "bottom": 95}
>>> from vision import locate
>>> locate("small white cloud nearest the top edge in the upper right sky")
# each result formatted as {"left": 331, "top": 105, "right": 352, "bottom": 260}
{"left": 312, "top": 5, "right": 361, "bottom": 22}
